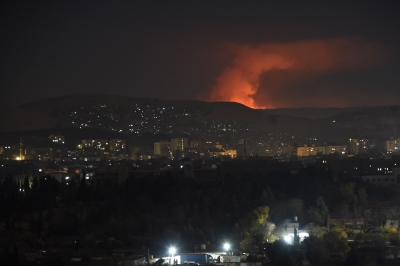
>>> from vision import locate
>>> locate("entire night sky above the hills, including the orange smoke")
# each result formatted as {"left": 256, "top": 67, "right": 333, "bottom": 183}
{"left": 0, "top": 0, "right": 400, "bottom": 108}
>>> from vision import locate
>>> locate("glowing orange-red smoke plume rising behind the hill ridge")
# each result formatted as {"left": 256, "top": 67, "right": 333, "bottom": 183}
{"left": 208, "top": 39, "right": 385, "bottom": 108}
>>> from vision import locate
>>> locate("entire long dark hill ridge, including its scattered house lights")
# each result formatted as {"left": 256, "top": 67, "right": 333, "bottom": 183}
{"left": 0, "top": 94, "right": 394, "bottom": 141}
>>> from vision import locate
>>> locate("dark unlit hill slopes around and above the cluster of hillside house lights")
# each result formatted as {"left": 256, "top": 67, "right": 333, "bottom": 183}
{"left": 1, "top": 93, "right": 394, "bottom": 141}
